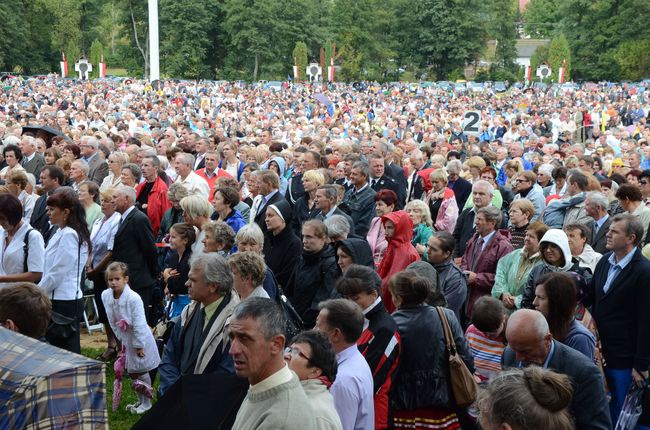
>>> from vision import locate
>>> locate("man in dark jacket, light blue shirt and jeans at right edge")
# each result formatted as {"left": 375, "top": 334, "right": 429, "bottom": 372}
{"left": 586, "top": 214, "right": 650, "bottom": 422}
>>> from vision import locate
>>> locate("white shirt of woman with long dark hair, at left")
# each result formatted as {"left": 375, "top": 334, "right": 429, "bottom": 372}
{"left": 38, "top": 227, "right": 88, "bottom": 300}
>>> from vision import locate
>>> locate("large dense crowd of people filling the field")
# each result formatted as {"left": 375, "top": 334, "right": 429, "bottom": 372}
{"left": 0, "top": 76, "right": 650, "bottom": 430}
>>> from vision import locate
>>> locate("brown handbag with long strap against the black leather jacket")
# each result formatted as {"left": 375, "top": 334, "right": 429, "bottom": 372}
{"left": 436, "top": 306, "right": 478, "bottom": 407}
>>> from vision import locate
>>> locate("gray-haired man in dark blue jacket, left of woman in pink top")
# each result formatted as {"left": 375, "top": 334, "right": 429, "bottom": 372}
{"left": 342, "top": 161, "right": 376, "bottom": 237}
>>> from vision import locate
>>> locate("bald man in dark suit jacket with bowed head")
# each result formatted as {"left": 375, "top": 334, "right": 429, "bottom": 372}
{"left": 501, "top": 309, "right": 612, "bottom": 430}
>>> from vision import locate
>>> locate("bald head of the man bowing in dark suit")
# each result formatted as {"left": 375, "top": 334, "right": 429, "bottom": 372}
{"left": 506, "top": 309, "right": 553, "bottom": 366}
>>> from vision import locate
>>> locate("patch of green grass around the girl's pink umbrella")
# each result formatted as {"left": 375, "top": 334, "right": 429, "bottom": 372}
{"left": 81, "top": 348, "right": 158, "bottom": 430}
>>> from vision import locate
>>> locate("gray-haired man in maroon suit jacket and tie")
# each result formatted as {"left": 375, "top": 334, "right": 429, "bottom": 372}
{"left": 460, "top": 205, "right": 513, "bottom": 316}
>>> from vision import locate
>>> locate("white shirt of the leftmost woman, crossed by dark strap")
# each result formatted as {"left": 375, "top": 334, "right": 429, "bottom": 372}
{"left": 0, "top": 222, "right": 45, "bottom": 288}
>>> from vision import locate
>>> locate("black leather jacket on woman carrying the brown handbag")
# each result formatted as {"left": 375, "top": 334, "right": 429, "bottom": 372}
{"left": 390, "top": 304, "right": 474, "bottom": 410}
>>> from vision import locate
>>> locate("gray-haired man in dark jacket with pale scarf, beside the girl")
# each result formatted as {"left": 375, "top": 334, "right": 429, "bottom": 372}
{"left": 158, "top": 253, "right": 239, "bottom": 395}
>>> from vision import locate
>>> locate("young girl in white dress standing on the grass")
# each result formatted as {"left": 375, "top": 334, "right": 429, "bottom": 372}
{"left": 102, "top": 262, "right": 160, "bottom": 414}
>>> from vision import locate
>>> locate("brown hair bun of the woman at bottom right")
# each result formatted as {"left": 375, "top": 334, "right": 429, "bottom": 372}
{"left": 524, "top": 366, "right": 573, "bottom": 412}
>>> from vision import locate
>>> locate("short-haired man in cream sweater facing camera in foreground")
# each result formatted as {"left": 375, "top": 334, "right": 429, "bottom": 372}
{"left": 228, "top": 297, "right": 316, "bottom": 430}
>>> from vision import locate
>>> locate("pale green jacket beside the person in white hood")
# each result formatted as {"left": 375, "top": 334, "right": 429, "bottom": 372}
{"left": 492, "top": 248, "right": 542, "bottom": 309}
